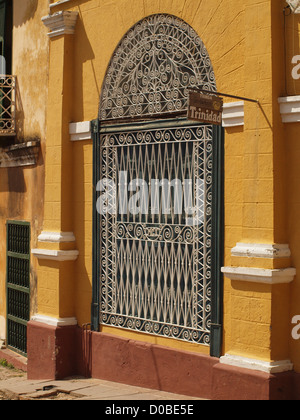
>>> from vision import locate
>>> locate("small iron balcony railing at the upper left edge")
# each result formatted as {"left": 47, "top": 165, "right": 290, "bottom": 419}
{"left": 0, "top": 75, "right": 16, "bottom": 136}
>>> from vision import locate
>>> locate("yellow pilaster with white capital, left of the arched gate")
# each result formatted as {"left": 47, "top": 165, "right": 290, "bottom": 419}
{"left": 32, "top": 11, "right": 79, "bottom": 325}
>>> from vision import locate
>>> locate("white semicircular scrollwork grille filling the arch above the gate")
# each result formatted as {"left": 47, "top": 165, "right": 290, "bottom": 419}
{"left": 99, "top": 14, "right": 216, "bottom": 120}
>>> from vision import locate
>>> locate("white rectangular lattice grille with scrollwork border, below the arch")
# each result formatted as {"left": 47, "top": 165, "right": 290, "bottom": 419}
{"left": 100, "top": 125, "right": 212, "bottom": 345}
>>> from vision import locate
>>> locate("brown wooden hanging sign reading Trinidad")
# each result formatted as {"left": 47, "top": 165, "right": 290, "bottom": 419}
{"left": 188, "top": 91, "right": 223, "bottom": 125}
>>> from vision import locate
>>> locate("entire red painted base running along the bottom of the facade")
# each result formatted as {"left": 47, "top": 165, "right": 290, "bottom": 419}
{"left": 28, "top": 322, "right": 300, "bottom": 400}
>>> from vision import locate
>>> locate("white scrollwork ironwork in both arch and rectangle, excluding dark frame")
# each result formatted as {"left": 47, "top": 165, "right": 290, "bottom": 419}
{"left": 99, "top": 14, "right": 216, "bottom": 345}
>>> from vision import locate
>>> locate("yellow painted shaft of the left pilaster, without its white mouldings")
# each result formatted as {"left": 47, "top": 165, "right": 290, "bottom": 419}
{"left": 37, "top": 28, "right": 76, "bottom": 318}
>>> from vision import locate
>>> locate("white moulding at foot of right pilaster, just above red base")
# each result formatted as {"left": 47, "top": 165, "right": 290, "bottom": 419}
{"left": 220, "top": 354, "right": 294, "bottom": 374}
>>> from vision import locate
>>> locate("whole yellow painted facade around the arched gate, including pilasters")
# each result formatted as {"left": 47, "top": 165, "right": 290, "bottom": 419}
{"left": 0, "top": 0, "right": 300, "bottom": 396}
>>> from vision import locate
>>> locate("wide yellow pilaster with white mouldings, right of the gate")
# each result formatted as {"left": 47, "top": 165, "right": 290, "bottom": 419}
{"left": 222, "top": 0, "right": 296, "bottom": 371}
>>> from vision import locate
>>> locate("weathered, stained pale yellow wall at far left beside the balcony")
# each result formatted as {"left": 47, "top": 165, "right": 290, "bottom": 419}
{"left": 0, "top": 0, "right": 48, "bottom": 337}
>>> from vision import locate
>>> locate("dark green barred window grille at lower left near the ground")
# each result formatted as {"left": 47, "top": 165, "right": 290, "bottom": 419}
{"left": 6, "top": 221, "right": 30, "bottom": 356}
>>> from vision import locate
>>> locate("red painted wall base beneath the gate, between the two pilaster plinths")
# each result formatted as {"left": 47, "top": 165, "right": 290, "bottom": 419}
{"left": 92, "top": 334, "right": 218, "bottom": 398}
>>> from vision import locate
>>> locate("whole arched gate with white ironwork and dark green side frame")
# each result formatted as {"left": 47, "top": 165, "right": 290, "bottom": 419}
{"left": 92, "top": 15, "right": 223, "bottom": 356}
